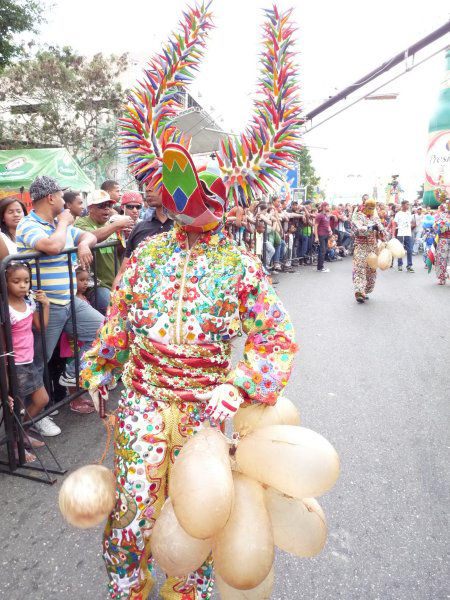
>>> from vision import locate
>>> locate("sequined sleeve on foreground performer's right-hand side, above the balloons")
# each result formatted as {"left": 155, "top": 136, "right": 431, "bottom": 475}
{"left": 226, "top": 254, "right": 297, "bottom": 404}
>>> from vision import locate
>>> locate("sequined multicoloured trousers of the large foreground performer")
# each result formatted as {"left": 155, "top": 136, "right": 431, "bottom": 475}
{"left": 103, "top": 390, "right": 213, "bottom": 600}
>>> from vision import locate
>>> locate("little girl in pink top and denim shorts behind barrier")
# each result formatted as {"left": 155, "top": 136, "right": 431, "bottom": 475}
{"left": 6, "top": 262, "right": 49, "bottom": 462}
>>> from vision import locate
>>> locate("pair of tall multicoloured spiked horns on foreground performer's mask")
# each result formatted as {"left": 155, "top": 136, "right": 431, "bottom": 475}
{"left": 120, "top": 2, "right": 302, "bottom": 205}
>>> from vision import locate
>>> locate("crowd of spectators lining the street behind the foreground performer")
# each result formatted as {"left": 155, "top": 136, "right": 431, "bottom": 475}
{"left": 0, "top": 176, "right": 442, "bottom": 458}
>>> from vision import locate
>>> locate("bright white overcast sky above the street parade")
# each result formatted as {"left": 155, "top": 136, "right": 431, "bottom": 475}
{"left": 41, "top": 0, "right": 450, "bottom": 199}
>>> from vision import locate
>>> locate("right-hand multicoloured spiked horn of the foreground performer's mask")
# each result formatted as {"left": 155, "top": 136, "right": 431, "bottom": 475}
{"left": 217, "top": 5, "right": 303, "bottom": 205}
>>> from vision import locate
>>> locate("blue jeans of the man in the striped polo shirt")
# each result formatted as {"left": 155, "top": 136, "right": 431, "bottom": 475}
{"left": 34, "top": 297, "right": 104, "bottom": 377}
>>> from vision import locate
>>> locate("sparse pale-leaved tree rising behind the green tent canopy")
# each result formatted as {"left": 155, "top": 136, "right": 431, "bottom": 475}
{"left": 0, "top": 47, "right": 128, "bottom": 179}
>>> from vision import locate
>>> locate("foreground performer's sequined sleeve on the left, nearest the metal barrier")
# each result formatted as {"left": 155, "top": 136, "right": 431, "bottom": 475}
{"left": 80, "top": 265, "right": 135, "bottom": 390}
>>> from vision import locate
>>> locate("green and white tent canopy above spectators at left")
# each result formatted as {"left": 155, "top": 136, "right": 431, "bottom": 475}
{"left": 0, "top": 148, "right": 95, "bottom": 192}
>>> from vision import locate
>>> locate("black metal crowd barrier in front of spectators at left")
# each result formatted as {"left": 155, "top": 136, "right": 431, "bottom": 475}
{"left": 0, "top": 241, "right": 119, "bottom": 484}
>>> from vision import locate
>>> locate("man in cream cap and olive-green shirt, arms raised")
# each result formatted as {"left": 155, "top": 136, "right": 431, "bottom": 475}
{"left": 76, "top": 190, "right": 133, "bottom": 314}
